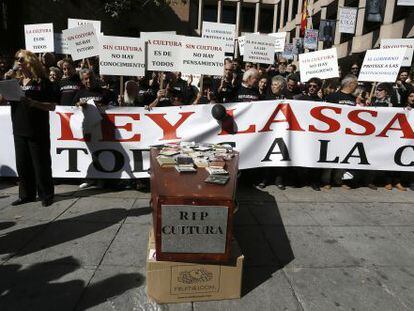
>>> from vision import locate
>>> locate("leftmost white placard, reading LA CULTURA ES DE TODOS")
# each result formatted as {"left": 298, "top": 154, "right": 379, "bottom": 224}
{"left": 24, "top": 23, "right": 55, "bottom": 53}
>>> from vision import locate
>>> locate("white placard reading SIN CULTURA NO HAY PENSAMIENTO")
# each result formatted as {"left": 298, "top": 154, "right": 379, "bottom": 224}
{"left": 181, "top": 37, "right": 225, "bottom": 75}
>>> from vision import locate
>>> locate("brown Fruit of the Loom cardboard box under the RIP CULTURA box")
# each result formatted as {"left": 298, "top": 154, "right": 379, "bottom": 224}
{"left": 147, "top": 229, "right": 244, "bottom": 303}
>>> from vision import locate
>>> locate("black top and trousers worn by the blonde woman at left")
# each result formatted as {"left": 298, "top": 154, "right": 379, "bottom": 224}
{"left": 11, "top": 79, "right": 58, "bottom": 200}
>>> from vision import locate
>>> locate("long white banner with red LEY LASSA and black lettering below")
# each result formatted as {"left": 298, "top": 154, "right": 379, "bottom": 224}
{"left": 0, "top": 100, "right": 414, "bottom": 178}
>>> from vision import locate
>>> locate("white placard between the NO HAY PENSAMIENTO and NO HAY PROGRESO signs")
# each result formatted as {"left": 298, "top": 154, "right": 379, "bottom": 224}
{"left": 243, "top": 34, "right": 275, "bottom": 64}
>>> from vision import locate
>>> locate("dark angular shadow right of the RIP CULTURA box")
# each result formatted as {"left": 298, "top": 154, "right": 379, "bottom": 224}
{"left": 234, "top": 187, "right": 295, "bottom": 295}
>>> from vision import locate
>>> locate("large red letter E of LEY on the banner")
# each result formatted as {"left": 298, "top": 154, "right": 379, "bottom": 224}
{"left": 101, "top": 113, "right": 141, "bottom": 142}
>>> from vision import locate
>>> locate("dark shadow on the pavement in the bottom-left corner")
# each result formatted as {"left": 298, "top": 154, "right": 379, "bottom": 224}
{"left": 0, "top": 257, "right": 144, "bottom": 311}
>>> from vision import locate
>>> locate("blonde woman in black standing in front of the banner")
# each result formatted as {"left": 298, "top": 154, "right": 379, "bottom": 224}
{"left": 0, "top": 50, "right": 58, "bottom": 206}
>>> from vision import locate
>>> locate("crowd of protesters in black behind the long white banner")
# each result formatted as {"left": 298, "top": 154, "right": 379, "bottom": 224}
{"left": 0, "top": 51, "right": 414, "bottom": 200}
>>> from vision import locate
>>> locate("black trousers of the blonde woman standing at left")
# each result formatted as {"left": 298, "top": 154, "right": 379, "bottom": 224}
{"left": 14, "top": 135, "right": 54, "bottom": 200}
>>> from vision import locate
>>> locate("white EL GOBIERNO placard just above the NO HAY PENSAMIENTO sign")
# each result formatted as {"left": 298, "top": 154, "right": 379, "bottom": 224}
{"left": 202, "top": 22, "right": 236, "bottom": 53}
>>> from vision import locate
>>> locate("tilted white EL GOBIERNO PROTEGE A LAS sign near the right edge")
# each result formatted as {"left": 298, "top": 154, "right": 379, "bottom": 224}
{"left": 358, "top": 48, "right": 406, "bottom": 83}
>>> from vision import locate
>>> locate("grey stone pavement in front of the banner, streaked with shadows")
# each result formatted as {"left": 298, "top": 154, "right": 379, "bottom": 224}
{"left": 0, "top": 182, "right": 414, "bottom": 311}
